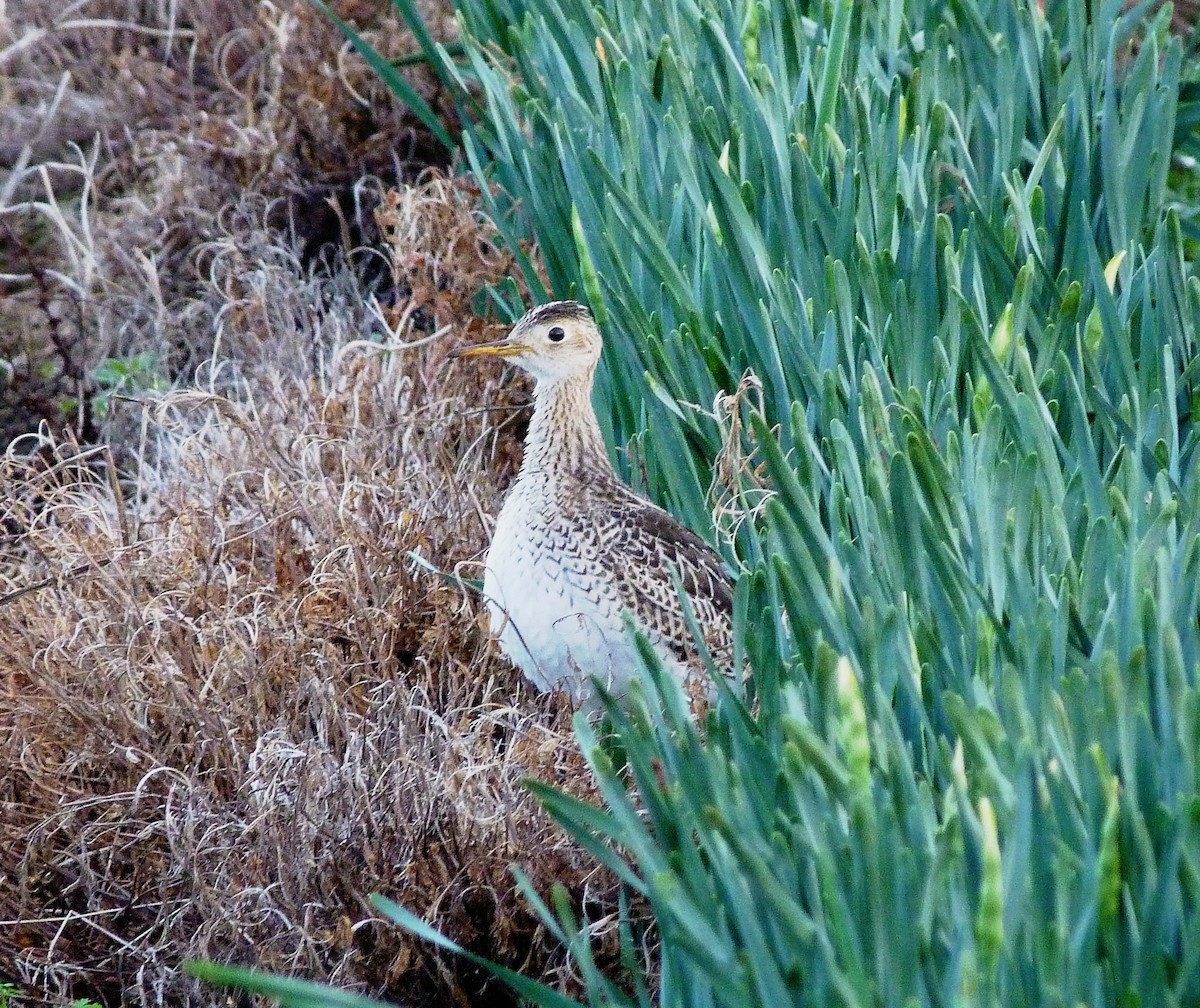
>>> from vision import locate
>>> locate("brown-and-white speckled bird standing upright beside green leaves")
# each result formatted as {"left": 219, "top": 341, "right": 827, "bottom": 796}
{"left": 452, "top": 301, "right": 733, "bottom": 712}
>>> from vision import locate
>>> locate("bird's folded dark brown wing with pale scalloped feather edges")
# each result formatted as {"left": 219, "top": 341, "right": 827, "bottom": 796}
{"left": 589, "top": 486, "right": 733, "bottom": 671}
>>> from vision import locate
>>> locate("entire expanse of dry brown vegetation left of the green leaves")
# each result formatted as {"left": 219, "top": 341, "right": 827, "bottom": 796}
{"left": 0, "top": 0, "right": 616, "bottom": 1004}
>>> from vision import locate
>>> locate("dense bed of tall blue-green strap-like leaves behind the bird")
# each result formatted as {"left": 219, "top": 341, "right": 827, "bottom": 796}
{"left": 199, "top": 0, "right": 1200, "bottom": 1008}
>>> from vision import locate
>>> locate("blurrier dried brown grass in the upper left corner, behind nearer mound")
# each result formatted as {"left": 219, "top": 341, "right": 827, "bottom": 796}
{"left": 0, "top": 0, "right": 452, "bottom": 443}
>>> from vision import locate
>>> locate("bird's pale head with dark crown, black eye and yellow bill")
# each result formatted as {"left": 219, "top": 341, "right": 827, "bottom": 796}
{"left": 450, "top": 301, "right": 601, "bottom": 384}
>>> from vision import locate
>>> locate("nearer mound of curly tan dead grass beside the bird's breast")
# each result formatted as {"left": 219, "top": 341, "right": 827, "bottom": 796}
{"left": 0, "top": 163, "right": 616, "bottom": 1004}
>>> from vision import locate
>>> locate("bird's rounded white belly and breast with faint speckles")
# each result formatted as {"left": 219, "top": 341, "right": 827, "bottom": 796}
{"left": 484, "top": 509, "right": 636, "bottom": 704}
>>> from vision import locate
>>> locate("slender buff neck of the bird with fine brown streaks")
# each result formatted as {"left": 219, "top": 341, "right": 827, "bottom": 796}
{"left": 521, "top": 371, "right": 612, "bottom": 474}
